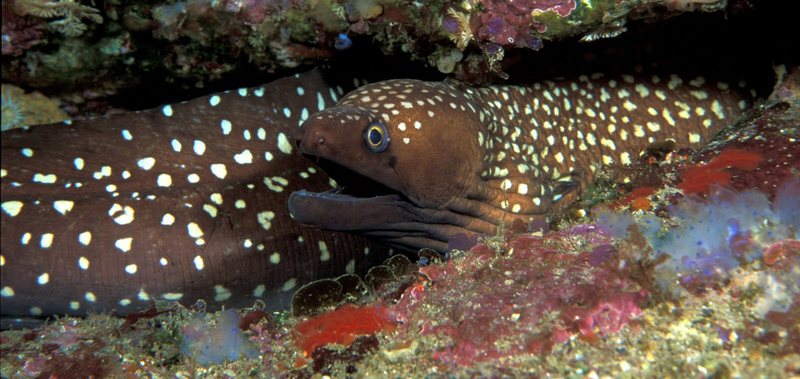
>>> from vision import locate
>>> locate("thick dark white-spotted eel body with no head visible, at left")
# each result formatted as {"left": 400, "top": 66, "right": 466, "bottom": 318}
{"left": 0, "top": 71, "right": 394, "bottom": 319}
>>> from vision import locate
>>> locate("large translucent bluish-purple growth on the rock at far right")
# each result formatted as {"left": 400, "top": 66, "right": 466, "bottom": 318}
{"left": 595, "top": 179, "right": 800, "bottom": 294}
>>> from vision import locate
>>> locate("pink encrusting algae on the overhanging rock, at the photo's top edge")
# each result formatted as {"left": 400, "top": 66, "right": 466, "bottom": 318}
{"left": 477, "top": 0, "right": 577, "bottom": 46}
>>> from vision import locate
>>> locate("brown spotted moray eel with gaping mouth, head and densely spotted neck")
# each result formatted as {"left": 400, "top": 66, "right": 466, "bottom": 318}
{"left": 289, "top": 73, "right": 755, "bottom": 254}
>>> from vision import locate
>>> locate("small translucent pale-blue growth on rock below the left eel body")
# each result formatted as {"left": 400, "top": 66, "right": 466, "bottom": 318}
{"left": 181, "top": 309, "right": 258, "bottom": 365}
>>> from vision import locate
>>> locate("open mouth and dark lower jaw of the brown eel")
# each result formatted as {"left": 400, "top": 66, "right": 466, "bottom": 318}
{"left": 288, "top": 154, "right": 492, "bottom": 251}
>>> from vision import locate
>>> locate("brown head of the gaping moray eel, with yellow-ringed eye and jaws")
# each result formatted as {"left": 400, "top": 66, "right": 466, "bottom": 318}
{"left": 289, "top": 80, "right": 544, "bottom": 250}
